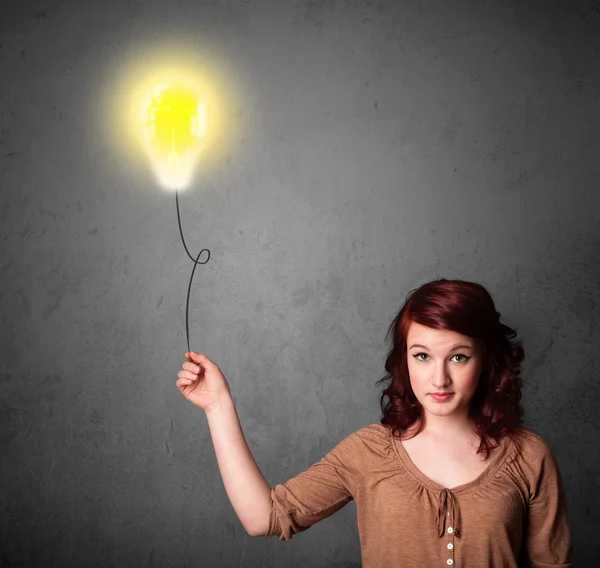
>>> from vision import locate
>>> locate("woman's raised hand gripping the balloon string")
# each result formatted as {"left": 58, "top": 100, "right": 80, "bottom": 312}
{"left": 175, "top": 351, "right": 231, "bottom": 412}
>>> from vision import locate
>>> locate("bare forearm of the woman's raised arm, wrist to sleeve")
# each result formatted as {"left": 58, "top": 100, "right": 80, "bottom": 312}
{"left": 206, "top": 397, "right": 271, "bottom": 536}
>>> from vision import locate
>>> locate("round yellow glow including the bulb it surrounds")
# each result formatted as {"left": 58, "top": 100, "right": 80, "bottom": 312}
{"left": 103, "top": 38, "right": 241, "bottom": 189}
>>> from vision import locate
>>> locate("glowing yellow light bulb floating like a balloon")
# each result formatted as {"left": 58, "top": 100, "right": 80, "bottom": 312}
{"left": 140, "top": 83, "right": 206, "bottom": 189}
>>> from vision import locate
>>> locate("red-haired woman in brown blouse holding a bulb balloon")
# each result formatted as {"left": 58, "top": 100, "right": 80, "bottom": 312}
{"left": 177, "top": 279, "right": 571, "bottom": 568}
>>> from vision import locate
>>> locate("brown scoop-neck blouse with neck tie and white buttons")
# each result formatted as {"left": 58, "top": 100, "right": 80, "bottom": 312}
{"left": 264, "top": 424, "right": 571, "bottom": 568}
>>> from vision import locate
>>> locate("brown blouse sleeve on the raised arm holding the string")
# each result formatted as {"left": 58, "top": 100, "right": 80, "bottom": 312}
{"left": 263, "top": 432, "right": 360, "bottom": 540}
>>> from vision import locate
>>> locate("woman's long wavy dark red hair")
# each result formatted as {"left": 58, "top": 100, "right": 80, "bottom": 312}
{"left": 376, "top": 279, "right": 525, "bottom": 459}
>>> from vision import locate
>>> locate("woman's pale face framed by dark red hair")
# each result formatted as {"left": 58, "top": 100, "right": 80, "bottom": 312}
{"left": 406, "top": 322, "right": 482, "bottom": 417}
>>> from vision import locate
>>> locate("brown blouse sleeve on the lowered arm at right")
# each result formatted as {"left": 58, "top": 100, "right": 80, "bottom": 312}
{"left": 525, "top": 442, "right": 572, "bottom": 568}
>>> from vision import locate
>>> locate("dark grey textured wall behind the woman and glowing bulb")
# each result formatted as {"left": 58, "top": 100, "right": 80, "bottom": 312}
{"left": 0, "top": 0, "right": 600, "bottom": 567}
